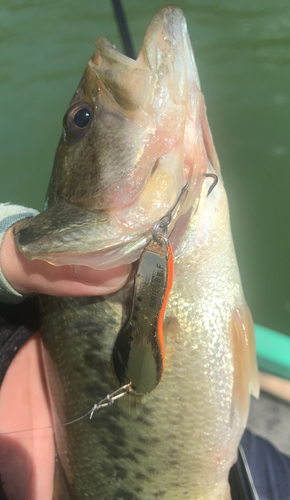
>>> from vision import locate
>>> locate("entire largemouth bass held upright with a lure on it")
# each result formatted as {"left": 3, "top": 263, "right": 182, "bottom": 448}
{"left": 15, "top": 6, "right": 259, "bottom": 500}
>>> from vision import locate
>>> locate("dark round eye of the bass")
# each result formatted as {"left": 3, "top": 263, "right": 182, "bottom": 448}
{"left": 63, "top": 101, "right": 92, "bottom": 137}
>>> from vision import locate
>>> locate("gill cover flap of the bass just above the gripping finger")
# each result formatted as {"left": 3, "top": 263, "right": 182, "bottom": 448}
{"left": 14, "top": 182, "right": 192, "bottom": 270}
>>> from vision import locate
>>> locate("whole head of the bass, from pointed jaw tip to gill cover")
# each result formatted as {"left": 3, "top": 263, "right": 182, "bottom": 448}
{"left": 15, "top": 6, "right": 219, "bottom": 269}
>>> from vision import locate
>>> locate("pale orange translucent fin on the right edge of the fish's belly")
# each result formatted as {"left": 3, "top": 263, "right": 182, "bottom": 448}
{"left": 231, "top": 302, "right": 259, "bottom": 424}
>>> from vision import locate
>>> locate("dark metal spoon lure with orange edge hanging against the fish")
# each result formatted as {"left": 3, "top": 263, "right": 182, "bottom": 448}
{"left": 113, "top": 183, "right": 189, "bottom": 394}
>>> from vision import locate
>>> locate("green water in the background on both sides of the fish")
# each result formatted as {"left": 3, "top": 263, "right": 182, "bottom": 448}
{"left": 0, "top": 0, "right": 290, "bottom": 335}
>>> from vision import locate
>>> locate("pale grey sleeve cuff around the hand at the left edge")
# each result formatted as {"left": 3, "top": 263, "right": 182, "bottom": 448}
{"left": 0, "top": 203, "right": 39, "bottom": 303}
